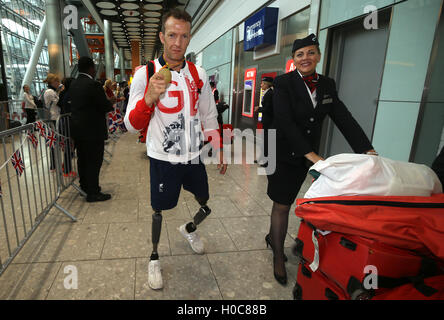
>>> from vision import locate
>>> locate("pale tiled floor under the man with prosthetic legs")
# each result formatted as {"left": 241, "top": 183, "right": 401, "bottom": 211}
{"left": 0, "top": 134, "right": 308, "bottom": 300}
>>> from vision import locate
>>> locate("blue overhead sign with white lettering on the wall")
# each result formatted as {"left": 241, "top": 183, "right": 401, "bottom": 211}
{"left": 244, "top": 8, "right": 279, "bottom": 51}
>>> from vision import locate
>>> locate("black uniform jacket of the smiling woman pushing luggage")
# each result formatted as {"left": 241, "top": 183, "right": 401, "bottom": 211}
{"left": 273, "top": 70, "right": 374, "bottom": 165}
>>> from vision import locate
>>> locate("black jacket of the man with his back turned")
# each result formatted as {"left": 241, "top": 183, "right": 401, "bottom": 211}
{"left": 69, "top": 74, "right": 113, "bottom": 141}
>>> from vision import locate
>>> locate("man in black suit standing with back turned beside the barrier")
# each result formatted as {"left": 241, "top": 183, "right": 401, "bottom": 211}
{"left": 69, "top": 57, "right": 113, "bottom": 202}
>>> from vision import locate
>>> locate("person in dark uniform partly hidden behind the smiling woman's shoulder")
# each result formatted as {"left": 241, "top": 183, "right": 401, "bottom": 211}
{"left": 254, "top": 77, "right": 274, "bottom": 167}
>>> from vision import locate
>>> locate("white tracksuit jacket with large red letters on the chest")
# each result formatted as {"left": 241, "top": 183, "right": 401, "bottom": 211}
{"left": 125, "top": 59, "right": 219, "bottom": 163}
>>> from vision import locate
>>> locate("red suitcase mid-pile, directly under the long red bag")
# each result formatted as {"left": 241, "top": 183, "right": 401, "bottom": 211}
{"left": 294, "top": 221, "right": 435, "bottom": 296}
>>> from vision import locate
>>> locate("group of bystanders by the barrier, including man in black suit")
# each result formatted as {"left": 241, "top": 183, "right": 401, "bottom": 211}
{"left": 23, "top": 57, "right": 129, "bottom": 202}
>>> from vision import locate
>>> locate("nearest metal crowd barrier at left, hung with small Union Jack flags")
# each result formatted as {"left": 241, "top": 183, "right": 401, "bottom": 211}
{"left": 0, "top": 115, "right": 80, "bottom": 275}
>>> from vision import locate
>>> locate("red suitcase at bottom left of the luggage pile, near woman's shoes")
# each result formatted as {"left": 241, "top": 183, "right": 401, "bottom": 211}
{"left": 293, "top": 263, "right": 348, "bottom": 300}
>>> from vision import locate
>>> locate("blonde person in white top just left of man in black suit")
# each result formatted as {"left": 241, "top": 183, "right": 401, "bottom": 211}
{"left": 43, "top": 73, "right": 65, "bottom": 171}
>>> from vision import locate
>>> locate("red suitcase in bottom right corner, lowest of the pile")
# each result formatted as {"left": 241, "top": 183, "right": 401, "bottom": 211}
{"left": 373, "top": 275, "right": 444, "bottom": 300}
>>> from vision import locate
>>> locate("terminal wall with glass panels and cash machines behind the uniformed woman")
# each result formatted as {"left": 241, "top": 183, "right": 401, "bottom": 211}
{"left": 192, "top": 0, "right": 444, "bottom": 165}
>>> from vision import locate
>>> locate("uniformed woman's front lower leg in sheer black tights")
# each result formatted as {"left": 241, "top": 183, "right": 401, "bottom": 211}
{"left": 270, "top": 202, "right": 290, "bottom": 276}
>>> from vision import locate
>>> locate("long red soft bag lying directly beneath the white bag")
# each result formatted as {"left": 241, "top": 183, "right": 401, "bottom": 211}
{"left": 295, "top": 194, "right": 444, "bottom": 260}
